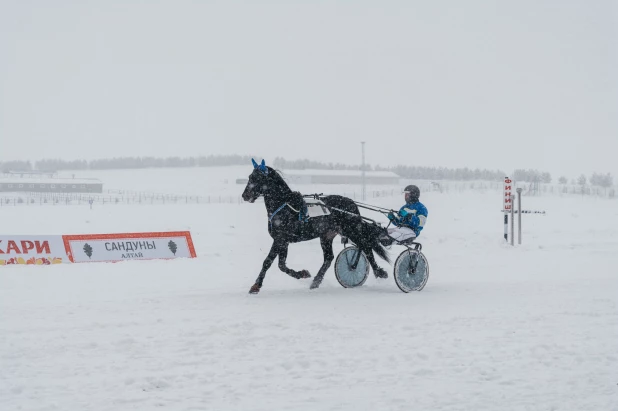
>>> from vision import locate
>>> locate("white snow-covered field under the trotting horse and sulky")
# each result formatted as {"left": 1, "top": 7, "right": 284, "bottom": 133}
{"left": 0, "top": 170, "right": 618, "bottom": 411}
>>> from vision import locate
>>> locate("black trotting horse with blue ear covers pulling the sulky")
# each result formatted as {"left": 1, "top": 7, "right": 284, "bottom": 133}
{"left": 242, "top": 160, "right": 389, "bottom": 294}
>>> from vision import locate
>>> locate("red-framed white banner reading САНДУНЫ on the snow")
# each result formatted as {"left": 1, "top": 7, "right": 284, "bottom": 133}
{"left": 63, "top": 231, "right": 196, "bottom": 263}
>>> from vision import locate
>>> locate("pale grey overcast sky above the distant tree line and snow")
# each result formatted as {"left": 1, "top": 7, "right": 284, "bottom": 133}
{"left": 0, "top": 0, "right": 618, "bottom": 177}
